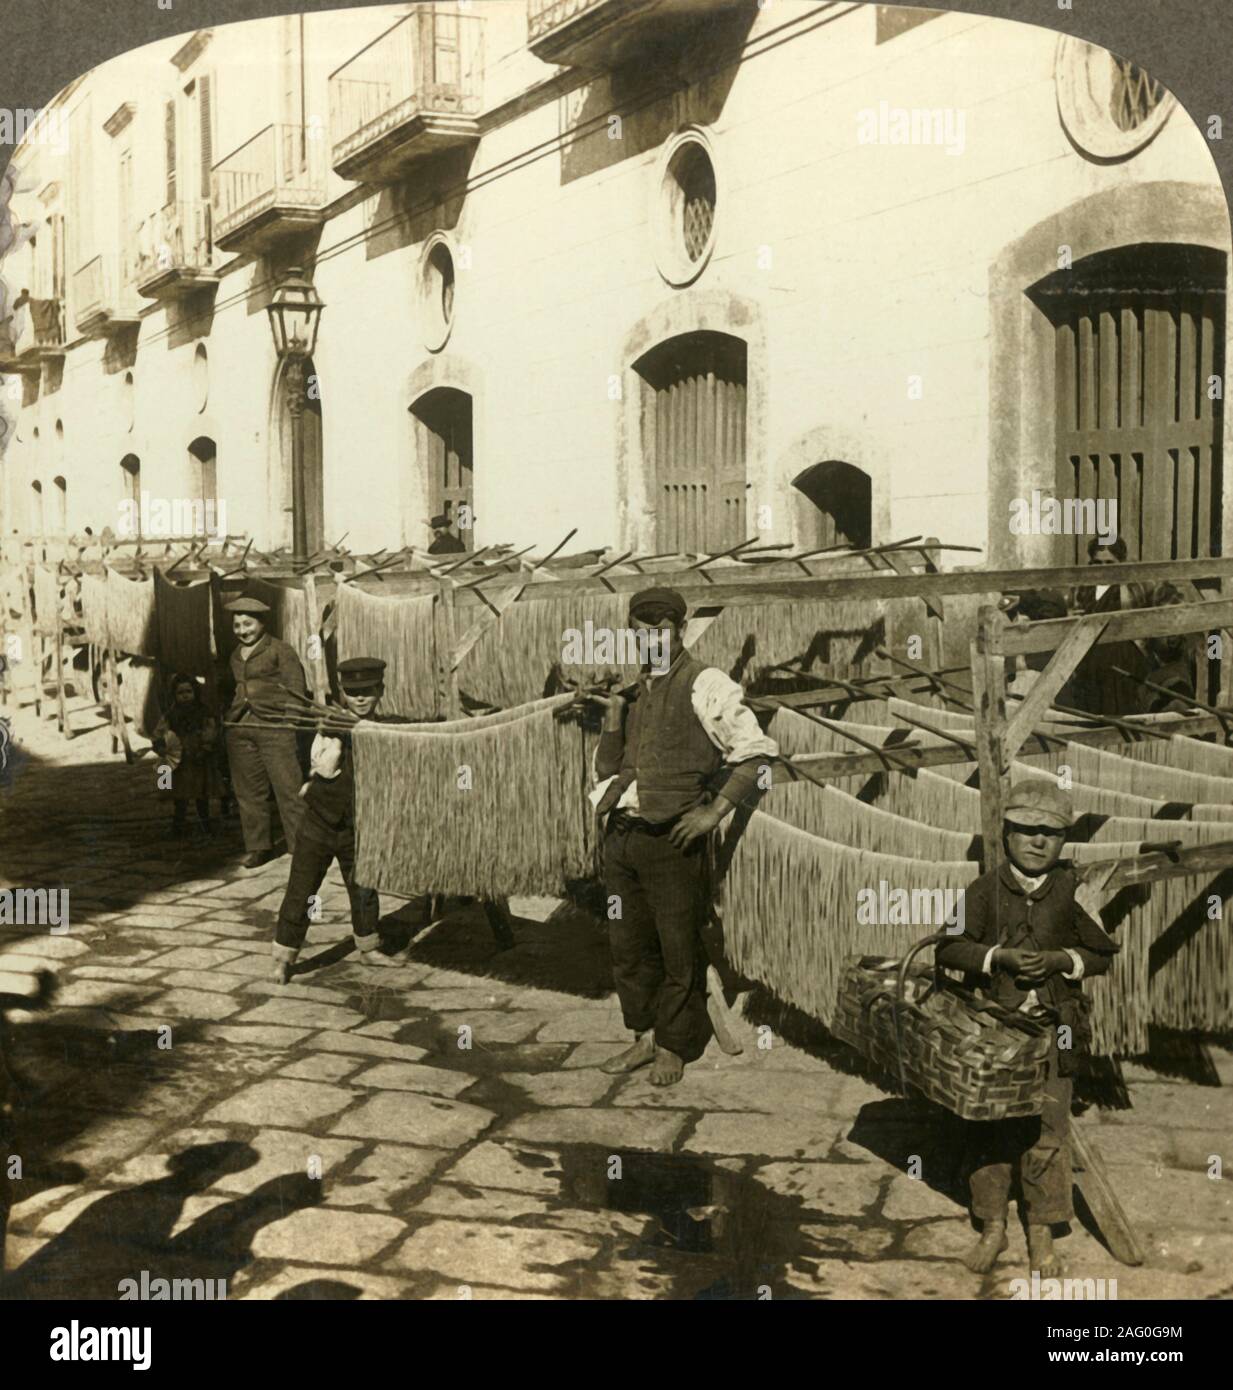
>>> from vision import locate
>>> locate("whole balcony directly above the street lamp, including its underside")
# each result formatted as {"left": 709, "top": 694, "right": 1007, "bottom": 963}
{"left": 211, "top": 124, "right": 325, "bottom": 252}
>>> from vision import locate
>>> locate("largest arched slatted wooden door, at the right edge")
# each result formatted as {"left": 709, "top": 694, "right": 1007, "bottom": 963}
{"left": 1031, "top": 246, "right": 1225, "bottom": 564}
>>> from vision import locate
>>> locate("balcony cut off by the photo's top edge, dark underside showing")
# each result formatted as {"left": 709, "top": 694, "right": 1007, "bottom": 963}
{"left": 527, "top": 0, "right": 748, "bottom": 71}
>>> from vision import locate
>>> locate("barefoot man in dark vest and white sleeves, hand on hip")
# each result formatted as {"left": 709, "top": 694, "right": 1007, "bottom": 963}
{"left": 592, "top": 589, "right": 778, "bottom": 1086}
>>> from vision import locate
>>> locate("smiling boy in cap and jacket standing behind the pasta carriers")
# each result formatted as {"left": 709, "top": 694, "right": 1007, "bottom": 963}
{"left": 225, "top": 598, "right": 307, "bottom": 869}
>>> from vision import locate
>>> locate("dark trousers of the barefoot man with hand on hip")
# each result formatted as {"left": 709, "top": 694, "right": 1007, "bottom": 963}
{"left": 603, "top": 817, "right": 710, "bottom": 1062}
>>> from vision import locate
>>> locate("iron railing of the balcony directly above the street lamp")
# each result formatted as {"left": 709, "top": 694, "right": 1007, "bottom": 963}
{"left": 211, "top": 124, "right": 325, "bottom": 242}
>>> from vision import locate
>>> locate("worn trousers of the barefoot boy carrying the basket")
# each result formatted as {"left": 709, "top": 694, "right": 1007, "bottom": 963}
{"left": 969, "top": 1045, "right": 1075, "bottom": 1226}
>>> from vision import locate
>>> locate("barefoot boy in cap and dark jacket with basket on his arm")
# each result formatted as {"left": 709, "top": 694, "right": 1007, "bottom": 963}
{"left": 936, "top": 778, "right": 1118, "bottom": 1279}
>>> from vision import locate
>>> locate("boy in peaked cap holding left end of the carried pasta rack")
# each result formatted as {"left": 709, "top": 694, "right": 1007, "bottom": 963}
{"left": 274, "top": 656, "right": 402, "bottom": 984}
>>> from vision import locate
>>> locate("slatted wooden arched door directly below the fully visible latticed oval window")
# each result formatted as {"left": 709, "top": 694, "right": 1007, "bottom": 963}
{"left": 634, "top": 332, "right": 749, "bottom": 553}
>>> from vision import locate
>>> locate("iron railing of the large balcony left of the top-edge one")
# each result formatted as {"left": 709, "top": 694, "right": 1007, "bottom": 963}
{"left": 329, "top": 4, "right": 484, "bottom": 167}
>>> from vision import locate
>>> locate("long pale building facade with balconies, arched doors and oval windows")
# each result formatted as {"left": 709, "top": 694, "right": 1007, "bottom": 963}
{"left": 0, "top": 0, "right": 1233, "bottom": 563}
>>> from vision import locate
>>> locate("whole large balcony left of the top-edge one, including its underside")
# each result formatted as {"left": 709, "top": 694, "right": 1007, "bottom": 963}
{"left": 329, "top": 6, "right": 484, "bottom": 183}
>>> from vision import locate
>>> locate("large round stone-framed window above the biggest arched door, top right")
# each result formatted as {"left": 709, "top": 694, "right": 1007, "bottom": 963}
{"left": 1055, "top": 38, "right": 1177, "bottom": 160}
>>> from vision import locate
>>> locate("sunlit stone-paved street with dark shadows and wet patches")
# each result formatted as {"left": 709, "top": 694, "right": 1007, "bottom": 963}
{"left": 0, "top": 710, "right": 1233, "bottom": 1300}
